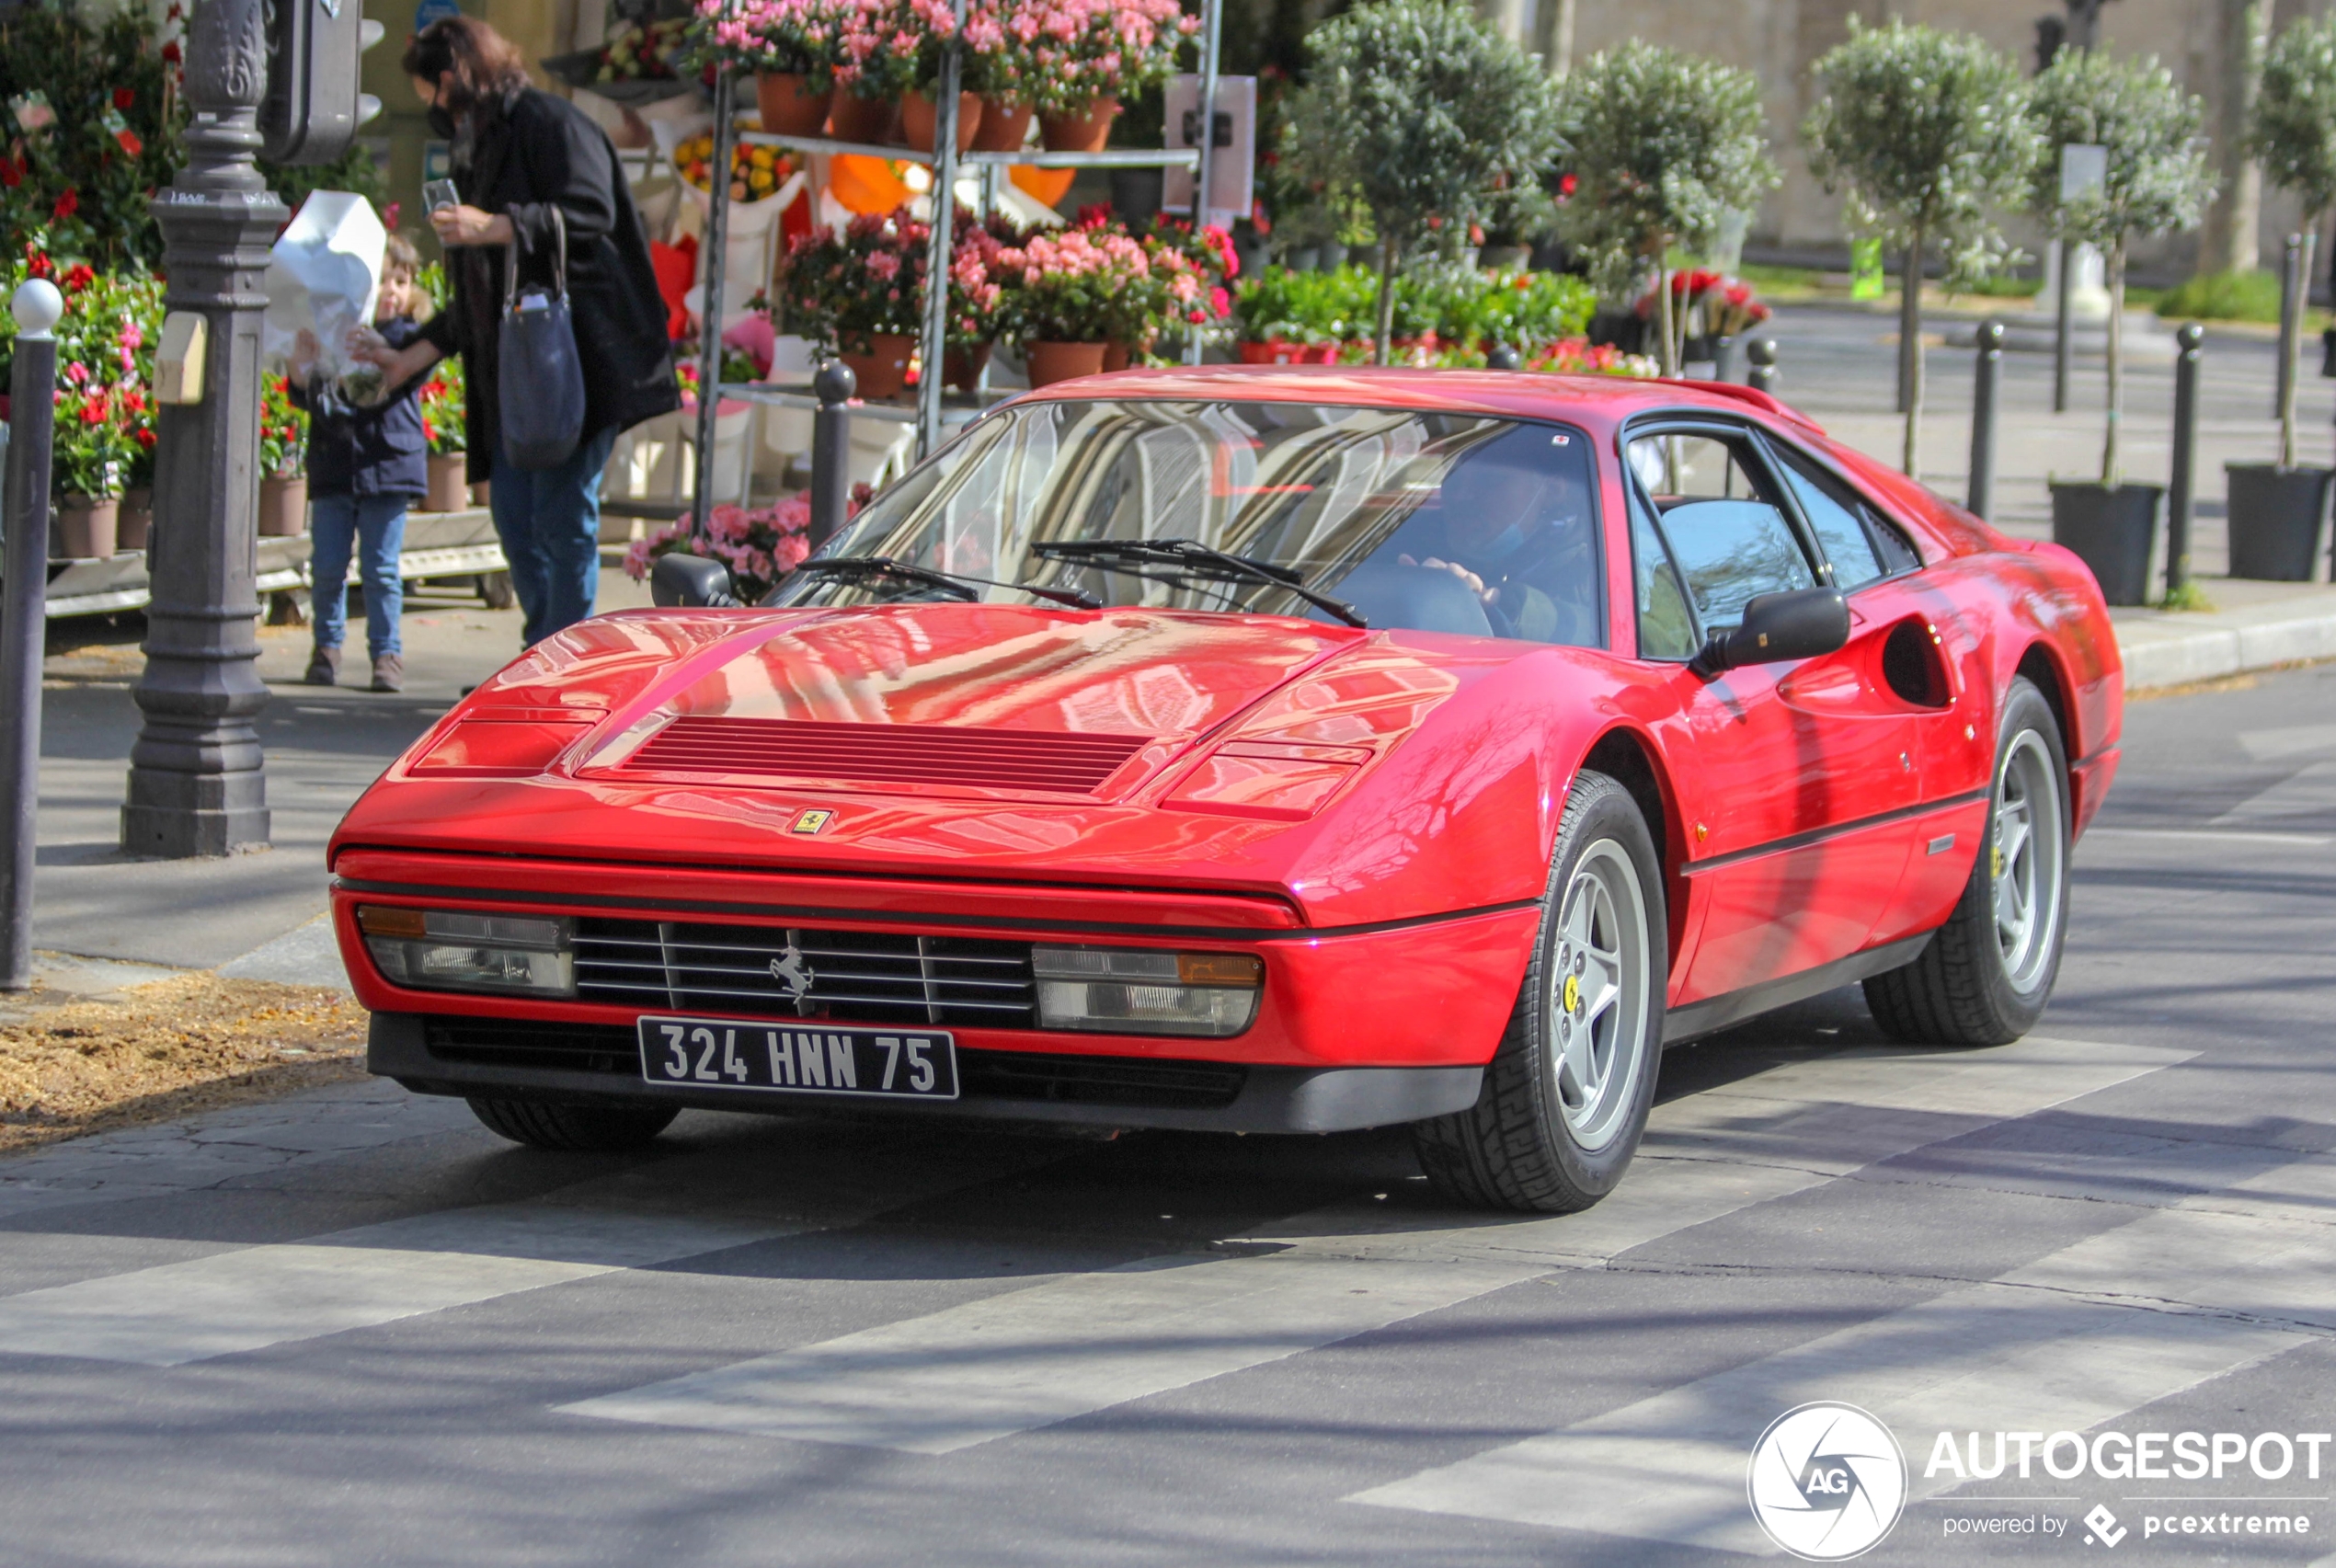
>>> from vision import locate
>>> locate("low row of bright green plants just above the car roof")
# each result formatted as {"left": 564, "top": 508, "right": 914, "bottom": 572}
{"left": 1233, "top": 267, "right": 1597, "bottom": 362}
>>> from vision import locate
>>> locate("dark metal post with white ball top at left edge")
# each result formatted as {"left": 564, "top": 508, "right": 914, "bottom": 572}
{"left": 0, "top": 278, "right": 65, "bottom": 990}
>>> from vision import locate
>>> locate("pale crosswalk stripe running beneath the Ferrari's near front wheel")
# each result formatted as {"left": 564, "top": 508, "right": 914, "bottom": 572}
{"left": 561, "top": 1040, "right": 2192, "bottom": 1453}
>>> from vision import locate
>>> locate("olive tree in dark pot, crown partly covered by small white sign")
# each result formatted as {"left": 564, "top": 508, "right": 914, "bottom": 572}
{"left": 2030, "top": 49, "right": 2215, "bottom": 605}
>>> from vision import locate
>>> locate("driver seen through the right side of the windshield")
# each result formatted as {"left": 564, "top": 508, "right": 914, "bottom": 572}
{"left": 1397, "top": 428, "right": 1597, "bottom": 645}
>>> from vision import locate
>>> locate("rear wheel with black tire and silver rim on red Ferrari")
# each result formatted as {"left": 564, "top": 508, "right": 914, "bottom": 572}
{"left": 1866, "top": 678, "right": 2069, "bottom": 1045}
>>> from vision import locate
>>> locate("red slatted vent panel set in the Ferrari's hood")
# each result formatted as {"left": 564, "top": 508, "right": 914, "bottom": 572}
{"left": 624, "top": 715, "right": 1150, "bottom": 795}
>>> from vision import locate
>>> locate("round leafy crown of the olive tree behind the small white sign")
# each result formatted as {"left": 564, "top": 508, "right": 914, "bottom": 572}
{"left": 2030, "top": 49, "right": 2215, "bottom": 250}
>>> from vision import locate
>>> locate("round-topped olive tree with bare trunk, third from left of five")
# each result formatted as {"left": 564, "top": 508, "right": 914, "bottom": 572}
{"left": 1801, "top": 17, "right": 2044, "bottom": 475}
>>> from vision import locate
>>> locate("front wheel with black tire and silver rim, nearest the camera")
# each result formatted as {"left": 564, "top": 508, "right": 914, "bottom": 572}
{"left": 1411, "top": 772, "right": 1670, "bottom": 1215}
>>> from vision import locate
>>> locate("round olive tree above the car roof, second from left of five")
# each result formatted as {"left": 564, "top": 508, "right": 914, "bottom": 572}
{"left": 1558, "top": 40, "right": 1782, "bottom": 376}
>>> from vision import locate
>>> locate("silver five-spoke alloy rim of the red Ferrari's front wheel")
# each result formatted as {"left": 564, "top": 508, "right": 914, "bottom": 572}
{"left": 1549, "top": 839, "right": 1649, "bottom": 1150}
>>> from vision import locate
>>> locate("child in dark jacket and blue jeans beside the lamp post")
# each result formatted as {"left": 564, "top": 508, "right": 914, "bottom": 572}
{"left": 290, "top": 234, "right": 429, "bottom": 692}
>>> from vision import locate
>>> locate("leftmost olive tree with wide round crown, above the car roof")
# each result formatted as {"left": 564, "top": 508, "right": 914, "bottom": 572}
{"left": 1288, "top": 0, "right": 1556, "bottom": 364}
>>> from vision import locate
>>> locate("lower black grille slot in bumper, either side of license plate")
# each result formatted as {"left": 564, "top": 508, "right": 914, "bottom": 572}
{"left": 423, "top": 1016, "right": 1247, "bottom": 1110}
